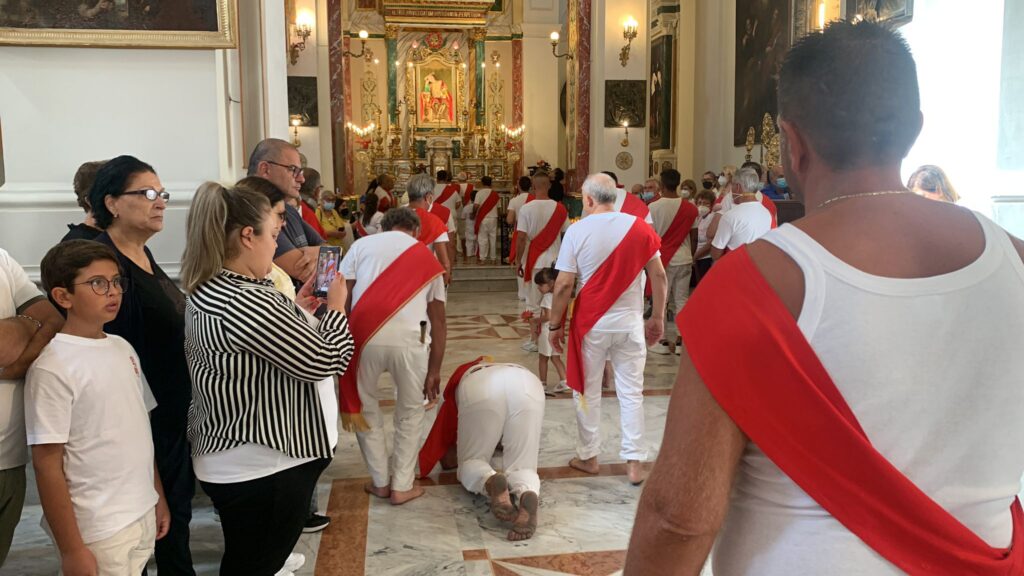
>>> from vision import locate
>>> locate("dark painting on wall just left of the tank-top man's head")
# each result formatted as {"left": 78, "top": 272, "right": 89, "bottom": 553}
{"left": 732, "top": 0, "right": 791, "bottom": 146}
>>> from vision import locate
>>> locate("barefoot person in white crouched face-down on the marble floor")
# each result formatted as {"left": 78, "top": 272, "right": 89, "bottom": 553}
{"left": 420, "top": 358, "right": 544, "bottom": 540}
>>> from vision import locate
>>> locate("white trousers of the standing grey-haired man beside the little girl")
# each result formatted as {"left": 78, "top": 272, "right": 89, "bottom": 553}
{"left": 572, "top": 324, "right": 647, "bottom": 460}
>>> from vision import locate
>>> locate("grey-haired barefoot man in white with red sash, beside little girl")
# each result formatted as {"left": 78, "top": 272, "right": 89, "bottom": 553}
{"left": 549, "top": 174, "right": 666, "bottom": 485}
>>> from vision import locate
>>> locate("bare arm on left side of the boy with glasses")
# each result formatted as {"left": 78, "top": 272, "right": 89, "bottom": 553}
{"left": 32, "top": 444, "right": 97, "bottom": 576}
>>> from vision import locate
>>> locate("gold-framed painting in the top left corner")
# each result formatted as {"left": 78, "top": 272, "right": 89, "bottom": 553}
{"left": 0, "top": 0, "right": 238, "bottom": 48}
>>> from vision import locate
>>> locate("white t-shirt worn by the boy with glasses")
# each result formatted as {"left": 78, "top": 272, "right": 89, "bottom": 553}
{"left": 25, "top": 334, "right": 158, "bottom": 543}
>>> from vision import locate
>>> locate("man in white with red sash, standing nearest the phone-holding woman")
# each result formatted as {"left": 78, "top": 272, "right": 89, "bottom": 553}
{"left": 341, "top": 208, "right": 446, "bottom": 504}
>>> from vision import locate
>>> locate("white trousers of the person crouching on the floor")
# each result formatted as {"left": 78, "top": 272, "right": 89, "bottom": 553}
{"left": 456, "top": 364, "right": 544, "bottom": 496}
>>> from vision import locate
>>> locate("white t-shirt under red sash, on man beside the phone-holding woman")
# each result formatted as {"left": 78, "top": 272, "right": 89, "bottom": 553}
{"left": 341, "top": 232, "right": 445, "bottom": 347}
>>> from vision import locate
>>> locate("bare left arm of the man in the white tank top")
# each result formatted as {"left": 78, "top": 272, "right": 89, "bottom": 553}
{"left": 624, "top": 354, "right": 746, "bottom": 576}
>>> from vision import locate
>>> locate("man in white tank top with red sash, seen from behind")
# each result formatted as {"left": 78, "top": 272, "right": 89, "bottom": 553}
{"left": 625, "top": 22, "right": 1024, "bottom": 576}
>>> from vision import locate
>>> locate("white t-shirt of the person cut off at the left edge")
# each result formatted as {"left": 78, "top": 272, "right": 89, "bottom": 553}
{"left": 0, "top": 249, "right": 43, "bottom": 470}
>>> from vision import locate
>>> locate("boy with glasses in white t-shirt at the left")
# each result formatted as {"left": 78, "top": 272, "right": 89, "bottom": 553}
{"left": 25, "top": 240, "right": 170, "bottom": 576}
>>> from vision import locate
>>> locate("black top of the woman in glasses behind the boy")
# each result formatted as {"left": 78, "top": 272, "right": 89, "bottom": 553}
{"left": 96, "top": 233, "right": 191, "bottom": 430}
